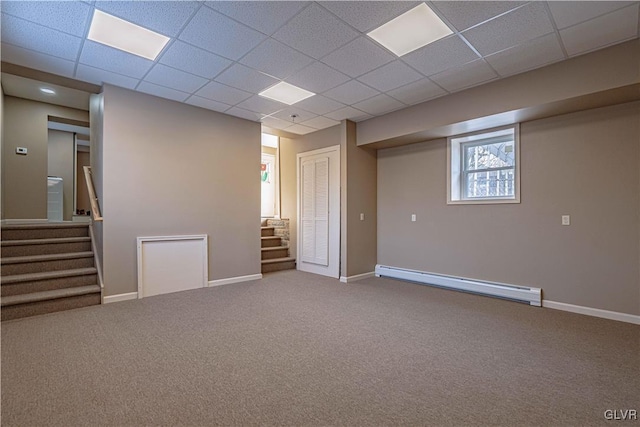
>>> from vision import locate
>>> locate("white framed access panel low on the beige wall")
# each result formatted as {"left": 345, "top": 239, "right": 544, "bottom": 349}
{"left": 138, "top": 235, "right": 209, "bottom": 298}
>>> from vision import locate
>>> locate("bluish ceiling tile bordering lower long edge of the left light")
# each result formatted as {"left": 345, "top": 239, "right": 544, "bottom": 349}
{"left": 80, "top": 40, "right": 153, "bottom": 79}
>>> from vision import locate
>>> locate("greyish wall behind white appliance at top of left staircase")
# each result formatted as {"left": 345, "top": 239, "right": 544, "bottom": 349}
{"left": 47, "top": 129, "right": 75, "bottom": 221}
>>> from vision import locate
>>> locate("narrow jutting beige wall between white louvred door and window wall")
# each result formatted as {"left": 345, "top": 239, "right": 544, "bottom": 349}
{"left": 341, "top": 120, "right": 377, "bottom": 277}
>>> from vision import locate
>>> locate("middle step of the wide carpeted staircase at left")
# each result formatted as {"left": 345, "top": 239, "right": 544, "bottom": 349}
{"left": 0, "top": 251, "right": 94, "bottom": 277}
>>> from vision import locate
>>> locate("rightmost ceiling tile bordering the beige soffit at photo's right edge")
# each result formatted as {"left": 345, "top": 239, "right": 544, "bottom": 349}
{"left": 560, "top": 4, "right": 638, "bottom": 56}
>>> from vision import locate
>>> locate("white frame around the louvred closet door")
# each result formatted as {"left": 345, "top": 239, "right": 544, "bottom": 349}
{"left": 296, "top": 145, "right": 342, "bottom": 279}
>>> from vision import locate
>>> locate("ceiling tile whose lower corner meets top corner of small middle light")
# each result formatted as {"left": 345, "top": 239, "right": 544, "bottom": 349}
{"left": 240, "top": 39, "right": 313, "bottom": 79}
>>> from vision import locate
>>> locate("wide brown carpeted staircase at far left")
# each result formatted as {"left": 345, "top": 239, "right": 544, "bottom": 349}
{"left": 0, "top": 222, "right": 101, "bottom": 320}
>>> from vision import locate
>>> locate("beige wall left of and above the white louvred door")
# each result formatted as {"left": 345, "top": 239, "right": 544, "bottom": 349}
{"left": 280, "top": 126, "right": 341, "bottom": 268}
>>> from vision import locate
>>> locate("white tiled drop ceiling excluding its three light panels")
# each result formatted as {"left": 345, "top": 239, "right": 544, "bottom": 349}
{"left": 1, "top": 1, "right": 640, "bottom": 134}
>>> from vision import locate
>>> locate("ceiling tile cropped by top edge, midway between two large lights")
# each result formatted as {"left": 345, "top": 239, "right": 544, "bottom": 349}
{"left": 205, "top": 1, "right": 309, "bottom": 34}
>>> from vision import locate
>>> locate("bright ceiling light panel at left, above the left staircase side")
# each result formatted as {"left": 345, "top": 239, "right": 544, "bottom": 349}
{"left": 88, "top": 9, "right": 169, "bottom": 61}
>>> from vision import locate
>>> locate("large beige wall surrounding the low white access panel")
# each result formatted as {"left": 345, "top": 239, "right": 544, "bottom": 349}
{"left": 102, "top": 85, "right": 261, "bottom": 295}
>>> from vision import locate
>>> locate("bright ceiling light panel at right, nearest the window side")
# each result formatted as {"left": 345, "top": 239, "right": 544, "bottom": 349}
{"left": 367, "top": 3, "right": 453, "bottom": 56}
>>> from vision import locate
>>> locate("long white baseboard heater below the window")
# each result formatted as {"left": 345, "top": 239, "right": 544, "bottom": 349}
{"left": 376, "top": 264, "right": 542, "bottom": 307}
